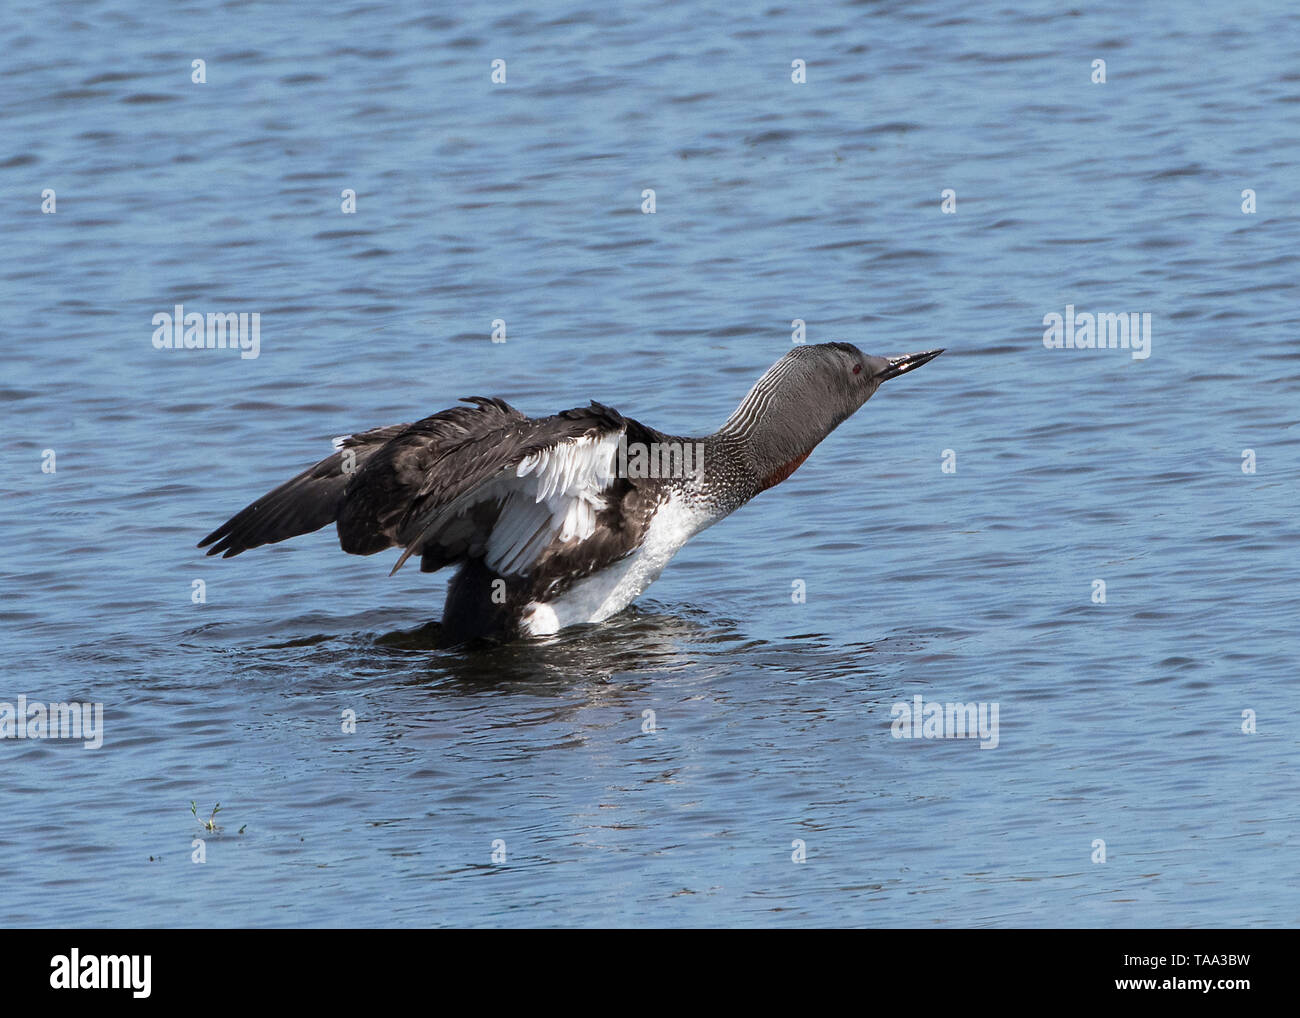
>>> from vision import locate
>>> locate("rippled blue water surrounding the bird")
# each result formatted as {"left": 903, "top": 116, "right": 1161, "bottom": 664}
{"left": 0, "top": 0, "right": 1300, "bottom": 926}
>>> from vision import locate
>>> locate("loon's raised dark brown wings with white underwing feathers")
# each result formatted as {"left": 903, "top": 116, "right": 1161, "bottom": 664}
{"left": 199, "top": 397, "right": 640, "bottom": 576}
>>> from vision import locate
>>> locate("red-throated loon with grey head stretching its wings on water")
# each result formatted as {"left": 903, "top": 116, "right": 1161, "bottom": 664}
{"left": 198, "top": 342, "right": 944, "bottom": 644}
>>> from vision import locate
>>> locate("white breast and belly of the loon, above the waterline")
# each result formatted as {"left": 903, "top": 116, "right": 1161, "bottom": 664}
{"left": 520, "top": 495, "right": 720, "bottom": 636}
